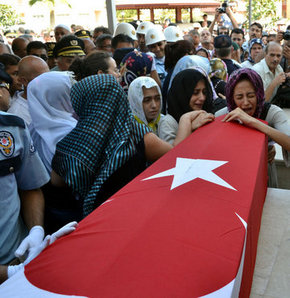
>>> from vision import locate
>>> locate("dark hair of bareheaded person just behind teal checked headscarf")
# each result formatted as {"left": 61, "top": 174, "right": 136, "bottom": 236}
{"left": 69, "top": 51, "right": 112, "bottom": 81}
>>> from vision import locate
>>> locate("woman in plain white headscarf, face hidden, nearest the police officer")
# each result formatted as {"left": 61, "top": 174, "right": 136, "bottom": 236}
{"left": 27, "top": 71, "right": 81, "bottom": 233}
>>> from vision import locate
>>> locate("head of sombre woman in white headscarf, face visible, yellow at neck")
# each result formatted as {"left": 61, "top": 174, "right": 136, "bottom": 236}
{"left": 128, "top": 77, "right": 163, "bottom": 133}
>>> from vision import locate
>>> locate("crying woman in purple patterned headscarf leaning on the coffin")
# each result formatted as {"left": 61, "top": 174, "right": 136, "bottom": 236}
{"left": 215, "top": 68, "right": 290, "bottom": 187}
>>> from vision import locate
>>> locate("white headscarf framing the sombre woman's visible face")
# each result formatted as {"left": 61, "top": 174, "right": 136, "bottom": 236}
{"left": 128, "top": 77, "right": 162, "bottom": 132}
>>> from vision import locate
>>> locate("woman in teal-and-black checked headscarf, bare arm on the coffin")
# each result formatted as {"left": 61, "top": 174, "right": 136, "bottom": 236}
{"left": 52, "top": 74, "right": 196, "bottom": 216}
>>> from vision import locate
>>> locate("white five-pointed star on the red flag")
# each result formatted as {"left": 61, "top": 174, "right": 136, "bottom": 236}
{"left": 143, "top": 157, "right": 236, "bottom": 190}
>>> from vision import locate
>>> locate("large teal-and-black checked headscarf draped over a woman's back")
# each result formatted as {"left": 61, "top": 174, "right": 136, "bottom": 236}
{"left": 52, "top": 74, "right": 149, "bottom": 216}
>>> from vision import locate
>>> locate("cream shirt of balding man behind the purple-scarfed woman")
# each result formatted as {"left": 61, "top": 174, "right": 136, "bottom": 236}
{"left": 252, "top": 58, "right": 284, "bottom": 100}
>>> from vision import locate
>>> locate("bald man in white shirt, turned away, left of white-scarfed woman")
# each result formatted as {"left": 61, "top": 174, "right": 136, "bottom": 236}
{"left": 8, "top": 56, "right": 49, "bottom": 125}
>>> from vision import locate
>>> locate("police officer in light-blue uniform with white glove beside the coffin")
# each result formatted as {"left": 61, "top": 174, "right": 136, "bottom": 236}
{"left": 0, "top": 67, "right": 49, "bottom": 280}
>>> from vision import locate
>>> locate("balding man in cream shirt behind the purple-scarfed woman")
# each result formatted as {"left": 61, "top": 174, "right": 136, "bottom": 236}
{"left": 253, "top": 41, "right": 287, "bottom": 101}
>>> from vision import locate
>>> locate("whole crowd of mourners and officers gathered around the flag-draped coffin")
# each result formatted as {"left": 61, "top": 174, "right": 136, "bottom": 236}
{"left": 0, "top": 7, "right": 290, "bottom": 281}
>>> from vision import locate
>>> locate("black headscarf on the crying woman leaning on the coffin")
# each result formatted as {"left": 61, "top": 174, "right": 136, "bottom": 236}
{"left": 167, "top": 69, "right": 213, "bottom": 122}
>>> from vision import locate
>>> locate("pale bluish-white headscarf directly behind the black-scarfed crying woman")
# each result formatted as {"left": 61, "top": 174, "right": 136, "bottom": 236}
{"left": 168, "top": 55, "right": 210, "bottom": 90}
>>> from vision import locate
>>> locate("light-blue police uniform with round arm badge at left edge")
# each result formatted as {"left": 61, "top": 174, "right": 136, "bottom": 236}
{"left": 0, "top": 111, "right": 49, "bottom": 264}
